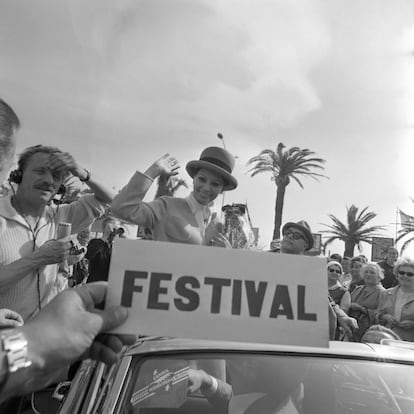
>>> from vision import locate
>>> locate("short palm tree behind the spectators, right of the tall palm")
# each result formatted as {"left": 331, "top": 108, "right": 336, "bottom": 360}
{"left": 321, "top": 205, "right": 384, "bottom": 257}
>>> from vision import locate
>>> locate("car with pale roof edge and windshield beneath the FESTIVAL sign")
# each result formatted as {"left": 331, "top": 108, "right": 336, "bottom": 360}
{"left": 59, "top": 337, "right": 414, "bottom": 414}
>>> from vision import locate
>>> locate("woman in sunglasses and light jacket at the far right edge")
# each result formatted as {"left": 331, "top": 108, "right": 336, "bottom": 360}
{"left": 377, "top": 257, "right": 414, "bottom": 341}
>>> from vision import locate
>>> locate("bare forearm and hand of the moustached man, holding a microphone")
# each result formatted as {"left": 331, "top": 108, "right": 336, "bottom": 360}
{"left": 0, "top": 239, "right": 71, "bottom": 289}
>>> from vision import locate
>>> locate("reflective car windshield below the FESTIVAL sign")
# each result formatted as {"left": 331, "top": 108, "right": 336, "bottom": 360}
{"left": 117, "top": 353, "right": 414, "bottom": 414}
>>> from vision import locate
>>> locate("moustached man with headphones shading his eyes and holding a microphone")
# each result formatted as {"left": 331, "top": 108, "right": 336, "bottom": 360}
{"left": 0, "top": 145, "right": 113, "bottom": 321}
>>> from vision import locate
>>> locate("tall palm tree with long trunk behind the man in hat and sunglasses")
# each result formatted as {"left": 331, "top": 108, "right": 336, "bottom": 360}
{"left": 247, "top": 142, "right": 327, "bottom": 240}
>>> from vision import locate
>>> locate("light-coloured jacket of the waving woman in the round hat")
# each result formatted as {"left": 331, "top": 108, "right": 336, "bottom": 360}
{"left": 111, "top": 171, "right": 210, "bottom": 244}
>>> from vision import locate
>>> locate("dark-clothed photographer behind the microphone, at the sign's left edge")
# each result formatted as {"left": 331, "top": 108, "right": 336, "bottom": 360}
{"left": 85, "top": 216, "right": 125, "bottom": 283}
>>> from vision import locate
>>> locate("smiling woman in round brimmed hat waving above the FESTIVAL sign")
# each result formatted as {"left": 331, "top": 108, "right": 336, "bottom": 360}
{"left": 111, "top": 147, "right": 237, "bottom": 247}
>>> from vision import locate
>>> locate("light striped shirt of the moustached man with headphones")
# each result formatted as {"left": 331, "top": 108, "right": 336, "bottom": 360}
{"left": 0, "top": 195, "right": 106, "bottom": 320}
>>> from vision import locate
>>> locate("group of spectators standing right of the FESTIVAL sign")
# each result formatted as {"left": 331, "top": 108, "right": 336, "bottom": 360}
{"left": 327, "top": 247, "right": 414, "bottom": 342}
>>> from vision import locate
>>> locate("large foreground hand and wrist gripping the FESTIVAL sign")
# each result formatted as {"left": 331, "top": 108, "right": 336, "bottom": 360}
{"left": 0, "top": 283, "right": 135, "bottom": 402}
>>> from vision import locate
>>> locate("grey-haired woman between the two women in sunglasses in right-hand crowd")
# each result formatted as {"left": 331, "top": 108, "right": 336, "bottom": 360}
{"left": 349, "top": 262, "right": 385, "bottom": 342}
